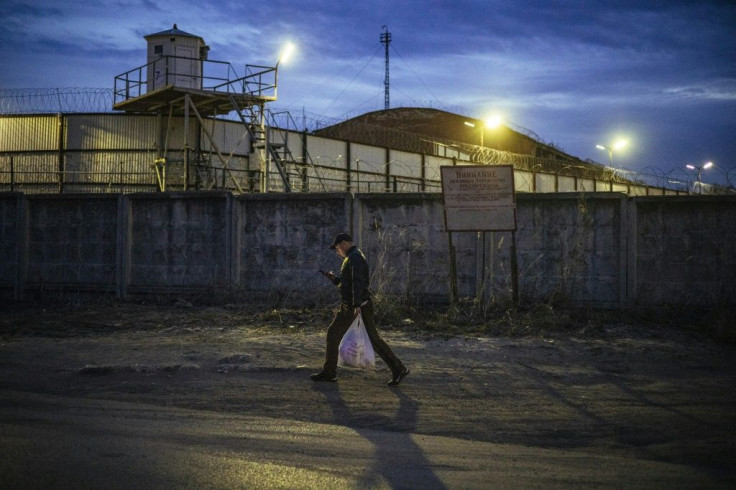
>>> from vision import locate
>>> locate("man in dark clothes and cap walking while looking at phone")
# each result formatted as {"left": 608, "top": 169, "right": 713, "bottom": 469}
{"left": 312, "top": 233, "right": 409, "bottom": 386}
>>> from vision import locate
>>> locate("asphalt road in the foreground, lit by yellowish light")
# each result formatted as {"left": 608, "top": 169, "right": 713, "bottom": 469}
{"left": 0, "top": 385, "right": 727, "bottom": 489}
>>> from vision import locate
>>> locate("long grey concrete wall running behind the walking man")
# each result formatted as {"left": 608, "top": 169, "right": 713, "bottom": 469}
{"left": 0, "top": 192, "right": 736, "bottom": 307}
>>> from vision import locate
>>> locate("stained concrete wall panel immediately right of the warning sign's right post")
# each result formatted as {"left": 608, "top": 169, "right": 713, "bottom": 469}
{"left": 516, "top": 194, "right": 626, "bottom": 304}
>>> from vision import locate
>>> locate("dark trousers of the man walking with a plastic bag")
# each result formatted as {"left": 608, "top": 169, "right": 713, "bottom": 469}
{"left": 322, "top": 300, "right": 404, "bottom": 376}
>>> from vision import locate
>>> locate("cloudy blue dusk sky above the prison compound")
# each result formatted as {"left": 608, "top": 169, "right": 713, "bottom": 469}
{"left": 0, "top": 0, "right": 736, "bottom": 185}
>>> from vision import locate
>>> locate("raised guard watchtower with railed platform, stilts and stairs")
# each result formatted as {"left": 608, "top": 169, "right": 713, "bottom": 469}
{"left": 113, "top": 24, "right": 291, "bottom": 192}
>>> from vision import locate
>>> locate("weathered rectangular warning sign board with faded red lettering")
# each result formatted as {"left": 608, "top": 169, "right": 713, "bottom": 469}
{"left": 440, "top": 165, "right": 516, "bottom": 231}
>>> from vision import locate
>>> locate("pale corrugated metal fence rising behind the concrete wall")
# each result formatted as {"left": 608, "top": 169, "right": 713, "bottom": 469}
{"left": 0, "top": 113, "right": 688, "bottom": 195}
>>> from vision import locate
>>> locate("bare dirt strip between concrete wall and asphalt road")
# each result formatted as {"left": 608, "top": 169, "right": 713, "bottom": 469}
{"left": 0, "top": 304, "right": 736, "bottom": 488}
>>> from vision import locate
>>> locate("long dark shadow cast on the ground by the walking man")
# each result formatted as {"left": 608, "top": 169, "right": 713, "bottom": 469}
{"left": 314, "top": 383, "right": 447, "bottom": 489}
